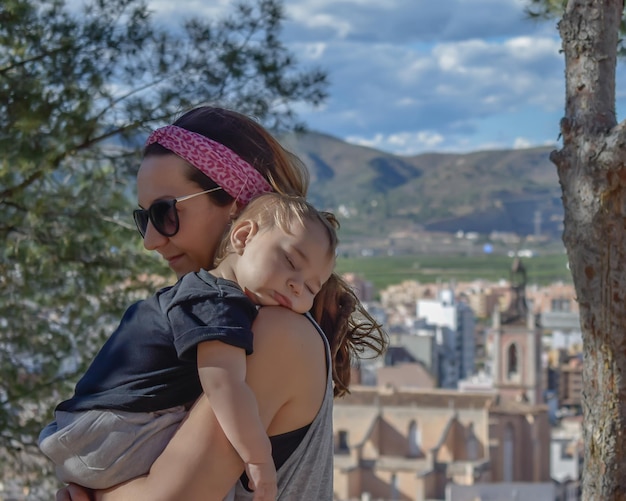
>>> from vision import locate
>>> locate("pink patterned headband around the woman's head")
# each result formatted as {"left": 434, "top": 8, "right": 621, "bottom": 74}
{"left": 146, "top": 125, "right": 274, "bottom": 205}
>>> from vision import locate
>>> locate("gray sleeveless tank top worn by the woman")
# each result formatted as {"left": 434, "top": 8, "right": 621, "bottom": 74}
{"left": 234, "top": 314, "right": 333, "bottom": 501}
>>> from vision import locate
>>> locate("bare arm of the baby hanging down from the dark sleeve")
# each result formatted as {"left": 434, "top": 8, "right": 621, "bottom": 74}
{"left": 198, "top": 341, "right": 277, "bottom": 501}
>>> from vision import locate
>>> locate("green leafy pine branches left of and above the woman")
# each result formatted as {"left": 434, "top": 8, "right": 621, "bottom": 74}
{"left": 0, "top": 0, "right": 326, "bottom": 490}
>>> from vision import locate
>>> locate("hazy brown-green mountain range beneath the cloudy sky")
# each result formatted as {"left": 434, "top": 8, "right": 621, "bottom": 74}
{"left": 281, "top": 132, "right": 563, "bottom": 238}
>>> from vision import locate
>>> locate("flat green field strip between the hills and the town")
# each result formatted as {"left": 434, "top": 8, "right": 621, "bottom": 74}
{"left": 336, "top": 254, "right": 572, "bottom": 291}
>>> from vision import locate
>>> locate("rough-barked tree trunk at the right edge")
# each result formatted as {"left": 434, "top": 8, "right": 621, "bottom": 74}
{"left": 551, "top": 0, "right": 626, "bottom": 501}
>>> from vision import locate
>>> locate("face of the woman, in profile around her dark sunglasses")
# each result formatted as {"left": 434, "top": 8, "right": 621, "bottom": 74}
{"left": 137, "top": 155, "right": 231, "bottom": 277}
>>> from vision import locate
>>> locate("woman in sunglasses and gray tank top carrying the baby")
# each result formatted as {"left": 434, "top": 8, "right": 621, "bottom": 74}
{"left": 57, "top": 107, "right": 386, "bottom": 501}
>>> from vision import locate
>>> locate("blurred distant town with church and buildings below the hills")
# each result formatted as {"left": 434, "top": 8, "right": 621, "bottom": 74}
{"left": 334, "top": 255, "right": 583, "bottom": 501}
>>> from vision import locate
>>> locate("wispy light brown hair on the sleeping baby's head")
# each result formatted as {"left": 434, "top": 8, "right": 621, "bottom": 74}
{"left": 214, "top": 193, "right": 339, "bottom": 265}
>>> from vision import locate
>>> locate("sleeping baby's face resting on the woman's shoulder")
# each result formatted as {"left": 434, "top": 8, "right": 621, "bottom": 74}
{"left": 236, "top": 220, "right": 335, "bottom": 313}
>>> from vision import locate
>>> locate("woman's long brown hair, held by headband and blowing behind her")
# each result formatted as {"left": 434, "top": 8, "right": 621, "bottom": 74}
{"left": 144, "top": 106, "right": 388, "bottom": 396}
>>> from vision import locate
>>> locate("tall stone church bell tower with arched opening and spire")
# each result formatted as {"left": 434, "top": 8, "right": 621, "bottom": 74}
{"left": 490, "top": 257, "right": 543, "bottom": 405}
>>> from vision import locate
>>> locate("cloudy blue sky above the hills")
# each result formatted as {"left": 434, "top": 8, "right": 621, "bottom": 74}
{"left": 149, "top": 0, "right": 626, "bottom": 155}
